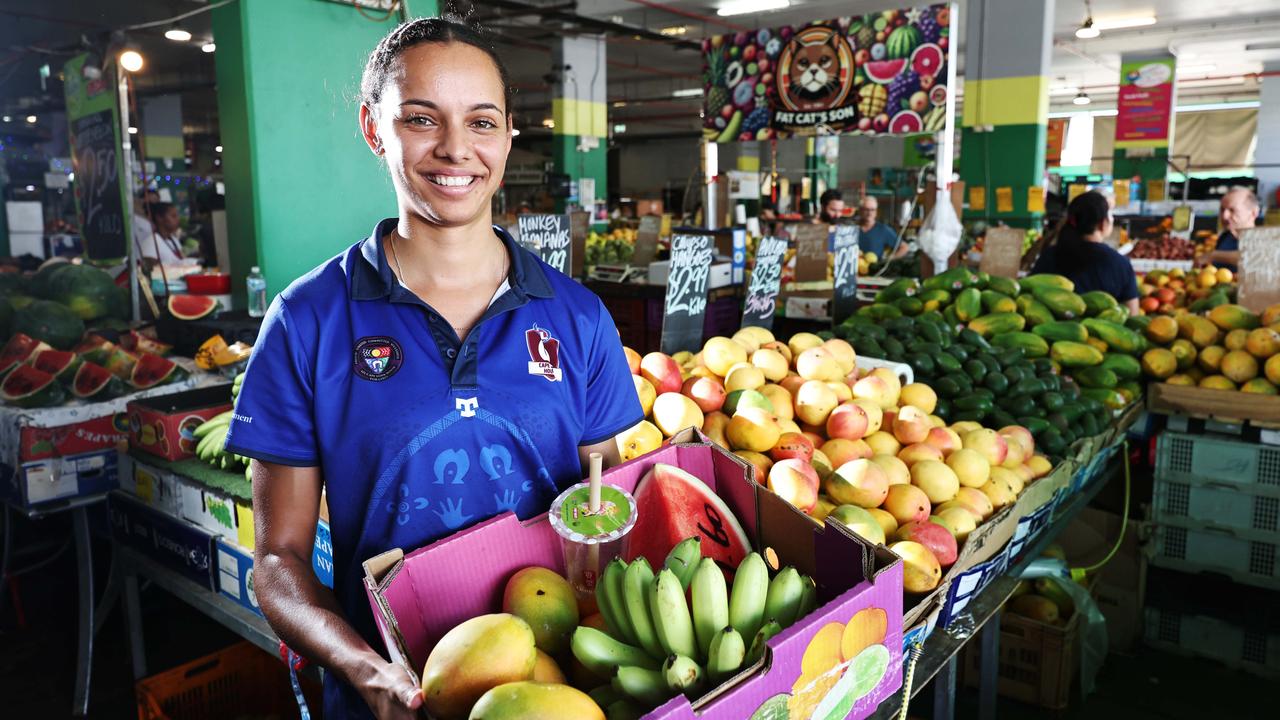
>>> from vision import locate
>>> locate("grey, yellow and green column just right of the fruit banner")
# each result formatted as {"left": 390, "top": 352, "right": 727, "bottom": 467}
{"left": 960, "top": 0, "right": 1053, "bottom": 227}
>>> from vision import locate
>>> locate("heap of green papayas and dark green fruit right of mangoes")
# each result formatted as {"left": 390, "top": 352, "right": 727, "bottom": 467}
{"left": 836, "top": 268, "right": 1147, "bottom": 456}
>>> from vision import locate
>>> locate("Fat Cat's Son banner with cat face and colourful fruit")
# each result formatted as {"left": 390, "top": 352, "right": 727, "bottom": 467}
{"left": 703, "top": 4, "right": 951, "bottom": 142}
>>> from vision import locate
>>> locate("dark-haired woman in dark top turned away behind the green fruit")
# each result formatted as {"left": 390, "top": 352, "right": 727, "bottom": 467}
{"left": 1032, "top": 191, "right": 1138, "bottom": 315}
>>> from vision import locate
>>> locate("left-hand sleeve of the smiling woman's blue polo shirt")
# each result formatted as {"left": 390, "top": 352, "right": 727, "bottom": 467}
{"left": 227, "top": 297, "right": 320, "bottom": 468}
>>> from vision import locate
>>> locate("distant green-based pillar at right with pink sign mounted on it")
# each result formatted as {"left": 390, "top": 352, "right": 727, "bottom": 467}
{"left": 1111, "top": 53, "right": 1176, "bottom": 200}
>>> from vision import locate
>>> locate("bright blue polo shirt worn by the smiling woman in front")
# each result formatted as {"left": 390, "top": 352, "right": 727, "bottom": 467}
{"left": 227, "top": 219, "right": 643, "bottom": 717}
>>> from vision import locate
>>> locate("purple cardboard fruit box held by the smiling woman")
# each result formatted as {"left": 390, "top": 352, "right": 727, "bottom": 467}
{"left": 364, "top": 429, "right": 902, "bottom": 720}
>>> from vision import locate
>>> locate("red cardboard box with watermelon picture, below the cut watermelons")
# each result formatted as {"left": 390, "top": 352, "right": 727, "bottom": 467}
{"left": 128, "top": 386, "right": 232, "bottom": 462}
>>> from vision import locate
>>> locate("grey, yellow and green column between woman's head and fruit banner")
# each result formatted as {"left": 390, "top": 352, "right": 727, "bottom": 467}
{"left": 552, "top": 36, "right": 609, "bottom": 211}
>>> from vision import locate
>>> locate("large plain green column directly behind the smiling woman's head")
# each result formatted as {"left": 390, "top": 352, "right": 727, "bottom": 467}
{"left": 212, "top": 0, "right": 436, "bottom": 299}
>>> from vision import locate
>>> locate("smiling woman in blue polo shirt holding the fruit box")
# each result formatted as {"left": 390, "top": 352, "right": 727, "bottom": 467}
{"left": 227, "top": 18, "right": 643, "bottom": 717}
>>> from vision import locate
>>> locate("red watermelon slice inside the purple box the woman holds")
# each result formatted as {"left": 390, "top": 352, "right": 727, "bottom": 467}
{"left": 627, "top": 462, "right": 751, "bottom": 569}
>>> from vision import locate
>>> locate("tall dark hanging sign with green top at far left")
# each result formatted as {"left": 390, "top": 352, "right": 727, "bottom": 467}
{"left": 63, "top": 54, "right": 131, "bottom": 261}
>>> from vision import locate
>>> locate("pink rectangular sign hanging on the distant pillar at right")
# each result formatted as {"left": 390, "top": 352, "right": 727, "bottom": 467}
{"left": 1115, "top": 55, "right": 1178, "bottom": 151}
